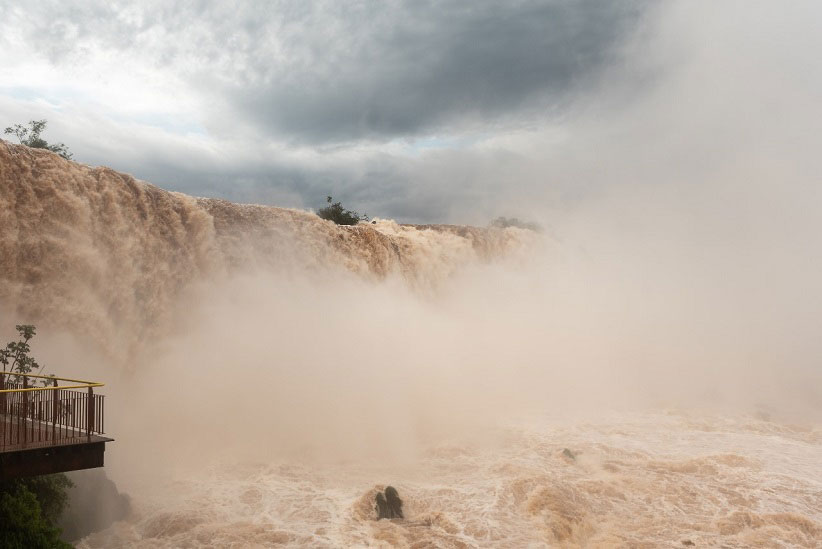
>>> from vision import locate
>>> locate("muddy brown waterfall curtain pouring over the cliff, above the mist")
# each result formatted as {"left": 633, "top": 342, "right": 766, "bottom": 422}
{"left": 0, "top": 141, "right": 523, "bottom": 359}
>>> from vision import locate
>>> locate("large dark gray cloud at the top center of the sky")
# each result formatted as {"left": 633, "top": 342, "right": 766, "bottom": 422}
{"left": 227, "top": 1, "right": 652, "bottom": 142}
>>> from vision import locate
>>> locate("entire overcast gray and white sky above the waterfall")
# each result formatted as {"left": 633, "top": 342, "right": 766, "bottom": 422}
{"left": 0, "top": 0, "right": 820, "bottom": 223}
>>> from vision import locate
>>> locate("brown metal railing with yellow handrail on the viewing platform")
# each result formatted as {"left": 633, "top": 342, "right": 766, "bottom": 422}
{"left": 0, "top": 372, "right": 104, "bottom": 452}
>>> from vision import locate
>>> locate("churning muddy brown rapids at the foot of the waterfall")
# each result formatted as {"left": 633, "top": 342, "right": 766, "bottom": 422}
{"left": 71, "top": 411, "right": 822, "bottom": 548}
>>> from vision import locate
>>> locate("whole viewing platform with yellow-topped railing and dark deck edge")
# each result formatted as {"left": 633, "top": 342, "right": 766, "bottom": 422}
{"left": 0, "top": 373, "right": 113, "bottom": 481}
